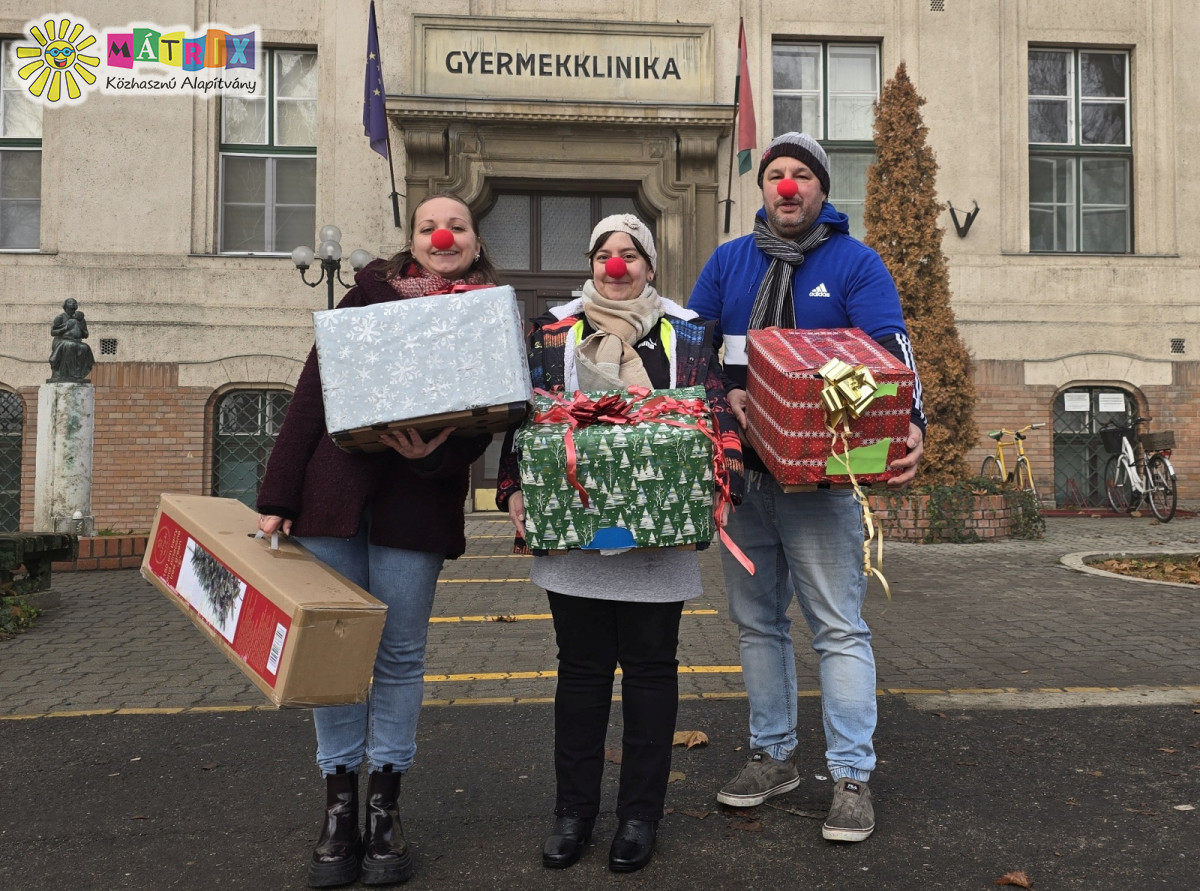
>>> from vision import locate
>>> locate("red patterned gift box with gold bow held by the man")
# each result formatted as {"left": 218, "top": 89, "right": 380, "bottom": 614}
{"left": 746, "top": 328, "right": 916, "bottom": 488}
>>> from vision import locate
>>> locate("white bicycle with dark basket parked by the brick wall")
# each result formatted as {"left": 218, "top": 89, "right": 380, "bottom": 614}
{"left": 1100, "top": 418, "right": 1178, "bottom": 522}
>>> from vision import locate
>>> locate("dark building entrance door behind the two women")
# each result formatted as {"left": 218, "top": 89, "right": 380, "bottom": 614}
{"left": 472, "top": 183, "right": 655, "bottom": 510}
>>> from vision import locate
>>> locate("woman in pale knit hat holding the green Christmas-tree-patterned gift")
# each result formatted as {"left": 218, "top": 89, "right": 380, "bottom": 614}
{"left": 497, "top": 214, "right": 742, "bottom": 872}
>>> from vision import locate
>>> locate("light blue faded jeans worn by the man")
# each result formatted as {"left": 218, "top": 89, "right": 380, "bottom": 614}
{"left": 721, "top": 471, "right": 876, "bottom": 782}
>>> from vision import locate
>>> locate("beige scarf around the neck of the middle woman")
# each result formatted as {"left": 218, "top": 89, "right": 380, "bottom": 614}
{"left": 575, "top": 279, "right": 662, "bottom": 390}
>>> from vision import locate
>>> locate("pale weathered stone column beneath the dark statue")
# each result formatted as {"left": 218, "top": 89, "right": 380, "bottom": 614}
{"left": 34, "top": 383, "right": 96, "bottom": 536}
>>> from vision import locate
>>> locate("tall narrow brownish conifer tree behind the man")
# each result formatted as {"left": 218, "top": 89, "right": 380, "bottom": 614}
{"left": 864, "top": 62, "right": 979, "bottom": 484}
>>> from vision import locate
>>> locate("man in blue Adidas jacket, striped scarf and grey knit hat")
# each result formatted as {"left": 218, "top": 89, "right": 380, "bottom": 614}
{"left": 688, "top": 132, "right": 925, "bottom": 842}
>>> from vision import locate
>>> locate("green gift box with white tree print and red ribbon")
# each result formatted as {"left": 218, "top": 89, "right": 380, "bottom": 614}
{"left": 516, "top": 387, "right": 720, "bottom": 550}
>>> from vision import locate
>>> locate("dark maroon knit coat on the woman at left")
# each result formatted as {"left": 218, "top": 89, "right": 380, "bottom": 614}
{"left": 258, "top": 261, "right": 492, "bottom": 558}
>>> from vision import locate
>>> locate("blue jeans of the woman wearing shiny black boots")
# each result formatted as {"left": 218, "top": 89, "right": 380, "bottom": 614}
{"left": 296, "top": 518, "right": 444, "bottom": 776}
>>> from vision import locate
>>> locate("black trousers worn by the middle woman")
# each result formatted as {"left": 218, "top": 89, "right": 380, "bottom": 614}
{"left": 546, "top": 591, "right": 683, "bottom": 820}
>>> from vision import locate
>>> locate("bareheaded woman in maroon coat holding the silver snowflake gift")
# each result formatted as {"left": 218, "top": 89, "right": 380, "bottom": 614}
{"left": 258, "top": 195, "right": 496, "bottom": 887}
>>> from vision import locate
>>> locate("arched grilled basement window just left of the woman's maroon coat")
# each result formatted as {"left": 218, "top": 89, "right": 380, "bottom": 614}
{"left": 212, "top": 390, "right": 292, "bottom": 507}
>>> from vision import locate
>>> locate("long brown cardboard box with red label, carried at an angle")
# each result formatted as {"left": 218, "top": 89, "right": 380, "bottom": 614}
{"left": 142, "top": 494, "right": 388, "bottom": 706}
